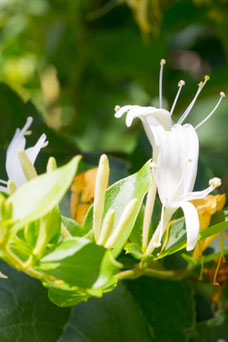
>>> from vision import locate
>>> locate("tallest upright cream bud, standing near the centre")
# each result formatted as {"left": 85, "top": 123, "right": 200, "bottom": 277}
{"left": 93, "top": 154, "right": 109, "bottom": 241}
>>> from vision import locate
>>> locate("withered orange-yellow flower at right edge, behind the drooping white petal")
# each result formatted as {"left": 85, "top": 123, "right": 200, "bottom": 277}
{"left": 191, "top": 194, "right": 226, "bottom": 259}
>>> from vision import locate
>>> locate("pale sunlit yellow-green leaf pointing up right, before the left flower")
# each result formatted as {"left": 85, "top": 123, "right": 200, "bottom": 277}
{"left": 7, "top": 156, "right": 81, "bottom": 231}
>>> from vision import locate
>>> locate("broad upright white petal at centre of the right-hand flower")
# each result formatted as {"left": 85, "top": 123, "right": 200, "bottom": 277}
{"left": 152, "top": 124, "right": 199, "bottom": 207}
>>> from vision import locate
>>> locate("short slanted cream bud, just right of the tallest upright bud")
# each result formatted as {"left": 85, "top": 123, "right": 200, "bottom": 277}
{"left": 105, "top": 198, "right": 138, "bottom": 248}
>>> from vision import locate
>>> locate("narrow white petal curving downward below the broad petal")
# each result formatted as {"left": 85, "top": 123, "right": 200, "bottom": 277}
{"left": 180, "top": 202, "right": 199, "bottom": 251}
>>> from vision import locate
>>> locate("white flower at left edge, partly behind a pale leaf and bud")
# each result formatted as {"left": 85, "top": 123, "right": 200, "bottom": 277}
{"left": 0, "top": 117, "right": 48, "bottom": 193}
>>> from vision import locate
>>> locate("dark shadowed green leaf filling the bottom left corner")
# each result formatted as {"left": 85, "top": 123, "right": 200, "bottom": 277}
{"left": 0, "top": 261, "right": 71, "bottom": 342}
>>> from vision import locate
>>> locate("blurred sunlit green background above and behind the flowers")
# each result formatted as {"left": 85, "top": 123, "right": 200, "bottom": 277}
{"left": 0, "top": 0, "right": 228, "bottom": 191}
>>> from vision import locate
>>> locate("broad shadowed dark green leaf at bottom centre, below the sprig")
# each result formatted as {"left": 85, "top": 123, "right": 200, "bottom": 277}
{"left": 59, "top": 284, "right": 155, "bottom": 342}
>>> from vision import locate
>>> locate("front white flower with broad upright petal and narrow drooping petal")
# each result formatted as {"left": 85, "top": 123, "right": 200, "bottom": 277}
{"left": 146, "top": 124, "right": 221, "bottom": 254}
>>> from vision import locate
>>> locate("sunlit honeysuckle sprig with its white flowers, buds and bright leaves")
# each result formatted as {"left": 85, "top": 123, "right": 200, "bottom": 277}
{"left": 0, "top": 60, "right": 228, "bottom": 306}
